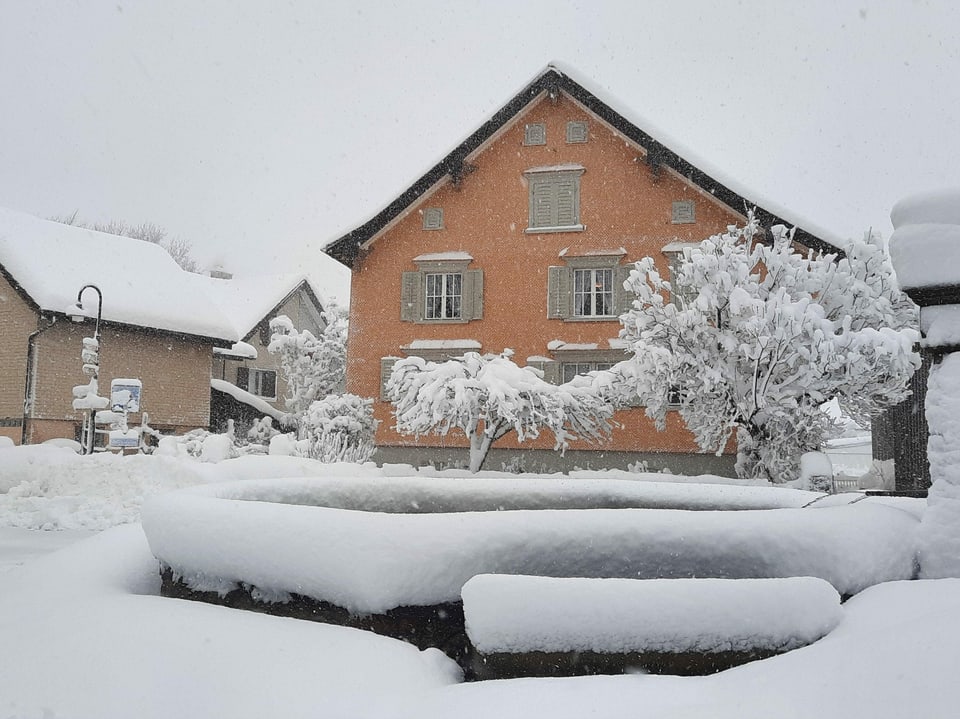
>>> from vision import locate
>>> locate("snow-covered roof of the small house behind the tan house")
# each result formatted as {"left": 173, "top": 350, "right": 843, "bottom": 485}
{"left": 193, "top": 275, "right": 325, "bottom": 338}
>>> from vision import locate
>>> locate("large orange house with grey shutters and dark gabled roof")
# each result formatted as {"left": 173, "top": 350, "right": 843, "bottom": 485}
{"left": 326, "top": 66, "right": 837, "bottom": 474}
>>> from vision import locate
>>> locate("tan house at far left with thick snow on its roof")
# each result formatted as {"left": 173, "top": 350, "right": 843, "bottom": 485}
{"left": 0, "top": 209, "right": 240, "bottom": 444}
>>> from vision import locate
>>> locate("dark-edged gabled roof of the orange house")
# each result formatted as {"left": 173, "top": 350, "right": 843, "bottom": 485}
{"left": 324, "top": 63, "right": 842, "bottom": 267}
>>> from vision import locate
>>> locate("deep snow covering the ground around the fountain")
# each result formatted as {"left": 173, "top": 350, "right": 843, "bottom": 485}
{"left": 0, "top": 450, "right": 960, "bottom": 719}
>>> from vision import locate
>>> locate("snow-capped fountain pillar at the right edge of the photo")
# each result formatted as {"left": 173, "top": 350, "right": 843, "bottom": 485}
{"left": 890, "top": 189, "right": 960, "bottom": 578}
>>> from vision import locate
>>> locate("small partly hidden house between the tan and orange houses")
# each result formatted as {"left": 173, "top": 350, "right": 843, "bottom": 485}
{"left": 197, "top": 273, "right": 326, "bottom": 431}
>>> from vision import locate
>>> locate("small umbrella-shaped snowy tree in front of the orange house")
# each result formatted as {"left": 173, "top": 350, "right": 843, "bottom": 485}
{"left": 386, "top": 349, "right": 613, "bottom": 472}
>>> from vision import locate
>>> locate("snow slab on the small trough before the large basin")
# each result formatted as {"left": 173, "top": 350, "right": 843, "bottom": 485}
{"left": 462, "top": 574, "right": 842, "bottom": 654}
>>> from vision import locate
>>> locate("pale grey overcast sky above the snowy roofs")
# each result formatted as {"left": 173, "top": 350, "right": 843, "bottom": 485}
{"left": 0, "top": 0, "right": 960, "bottom": 298}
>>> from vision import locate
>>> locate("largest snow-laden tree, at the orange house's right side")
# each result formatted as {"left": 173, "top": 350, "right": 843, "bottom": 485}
{"left": 620, "top": 214, "right": 919, "bottom": 482}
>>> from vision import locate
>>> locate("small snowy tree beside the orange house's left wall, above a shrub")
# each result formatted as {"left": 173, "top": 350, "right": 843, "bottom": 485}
{"left": 267, "top": 304, "right": 347, "bottom": 417}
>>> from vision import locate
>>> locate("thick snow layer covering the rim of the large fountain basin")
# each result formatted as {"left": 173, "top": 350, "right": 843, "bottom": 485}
{"left": 142, "top": 478, "right": 917, "bottom": 613}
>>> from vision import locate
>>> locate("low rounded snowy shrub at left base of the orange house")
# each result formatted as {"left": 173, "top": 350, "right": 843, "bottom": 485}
{"left": 298, "top": 394, "right": 377, "bottom": 464}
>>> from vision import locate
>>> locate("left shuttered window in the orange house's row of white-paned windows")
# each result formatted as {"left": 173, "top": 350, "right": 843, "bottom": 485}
{"left": 400, "top": 252, "right": 483, "bottom": 323}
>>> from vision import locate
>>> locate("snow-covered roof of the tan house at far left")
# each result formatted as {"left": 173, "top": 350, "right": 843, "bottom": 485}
{"left": 0, "top": 208, "right": 240, "bottom": 342}
